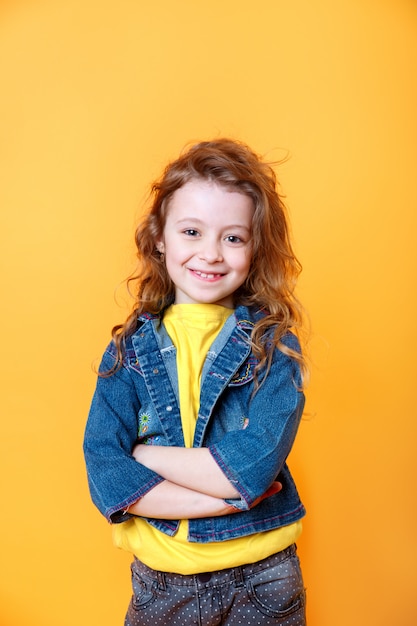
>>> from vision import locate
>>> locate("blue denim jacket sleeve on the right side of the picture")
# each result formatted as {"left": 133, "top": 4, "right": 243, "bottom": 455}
{"left": 209, "top": 336, "right": 304, "bottom": 510}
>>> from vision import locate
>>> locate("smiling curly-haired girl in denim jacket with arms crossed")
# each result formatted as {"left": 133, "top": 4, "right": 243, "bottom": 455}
{"left": 84, "top": 139, "right": 306, "bottom": 626}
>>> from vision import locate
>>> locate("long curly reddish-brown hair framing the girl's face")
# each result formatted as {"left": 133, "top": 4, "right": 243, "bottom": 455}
{"left": 105, "top": 138, "right": 307, "bottom": 382}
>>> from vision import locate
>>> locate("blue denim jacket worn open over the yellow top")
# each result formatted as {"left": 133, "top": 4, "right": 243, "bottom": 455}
{"left": 84, "top": 306, "right": 305, "bottom": 542}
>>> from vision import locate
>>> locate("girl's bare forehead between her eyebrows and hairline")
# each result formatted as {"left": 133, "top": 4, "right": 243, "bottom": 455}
{"left": 167, "top": 180, "right": 255, "bottom": 227}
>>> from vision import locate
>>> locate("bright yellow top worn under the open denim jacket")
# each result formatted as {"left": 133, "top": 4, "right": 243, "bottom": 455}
{"left": 113, "top": 304, "right": 302, "bottom": 574}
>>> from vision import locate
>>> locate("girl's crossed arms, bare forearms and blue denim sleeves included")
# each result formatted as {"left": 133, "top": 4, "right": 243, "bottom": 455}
{"left": 84, "top": 336, "right": 303, "bottom": 522}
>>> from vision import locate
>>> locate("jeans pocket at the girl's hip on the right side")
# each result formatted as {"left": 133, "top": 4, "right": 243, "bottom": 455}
{"left": 246, "top": 555, "right": 305, "bottom": 623}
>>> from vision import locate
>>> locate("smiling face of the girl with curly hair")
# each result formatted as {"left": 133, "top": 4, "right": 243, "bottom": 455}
{"left": 157, "top": 180, "right": 254, "bottom": 308}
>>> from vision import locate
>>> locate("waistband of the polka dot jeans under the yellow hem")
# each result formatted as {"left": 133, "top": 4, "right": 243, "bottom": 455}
{"left": 132, "top": 544, "right": 297, "bottom": 588}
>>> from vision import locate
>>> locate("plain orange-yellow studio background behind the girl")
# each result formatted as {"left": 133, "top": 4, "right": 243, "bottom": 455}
{"left": 0, "top": 0, "right": 417, "bottom": 626}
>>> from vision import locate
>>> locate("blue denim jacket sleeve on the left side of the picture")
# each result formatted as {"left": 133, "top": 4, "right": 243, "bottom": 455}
{"left": 84, "top": 350, "right": 163, "bottom": 522}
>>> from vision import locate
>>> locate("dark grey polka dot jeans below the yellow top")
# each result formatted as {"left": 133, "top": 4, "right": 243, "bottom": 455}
{"left": 125, "top": 545, "right": 306, "bottom": 626}
